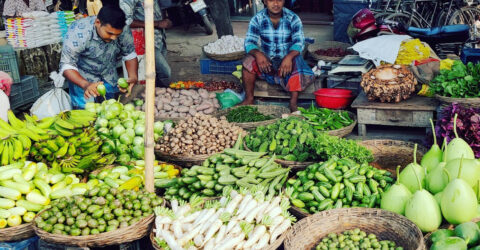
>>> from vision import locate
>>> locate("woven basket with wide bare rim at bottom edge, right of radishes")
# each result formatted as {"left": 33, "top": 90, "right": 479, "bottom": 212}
{"left": 284, "top": 208, "right": 425, "bottom": 250}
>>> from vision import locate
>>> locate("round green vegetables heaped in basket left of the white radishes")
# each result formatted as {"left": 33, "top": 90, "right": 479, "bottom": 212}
{"left": 35, "top": 184, "right": 163, "bottom": 236}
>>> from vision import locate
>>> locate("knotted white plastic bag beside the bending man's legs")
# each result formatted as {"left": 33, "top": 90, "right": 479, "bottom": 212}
{"left": 30, "top": 72, "right": 72, "bottom": 119}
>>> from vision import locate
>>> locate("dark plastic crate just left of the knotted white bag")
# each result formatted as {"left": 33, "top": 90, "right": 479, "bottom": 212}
{"left": 10, "top": 76, "right": 40, "bottom": 109}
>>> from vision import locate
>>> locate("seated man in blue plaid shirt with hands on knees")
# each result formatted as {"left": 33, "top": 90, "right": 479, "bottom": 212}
{"left": 242, "top": 0, "right": 314, "bottom": 111}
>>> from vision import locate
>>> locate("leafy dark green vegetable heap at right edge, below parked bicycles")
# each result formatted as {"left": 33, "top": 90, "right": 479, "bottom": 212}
{"left": 429, "top": 61, "right": 480, "bottom": 98}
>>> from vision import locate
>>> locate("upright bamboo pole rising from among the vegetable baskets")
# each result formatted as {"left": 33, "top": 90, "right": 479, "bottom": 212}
{"left": 144, "top": 0, "right": 155, "bottom": 192}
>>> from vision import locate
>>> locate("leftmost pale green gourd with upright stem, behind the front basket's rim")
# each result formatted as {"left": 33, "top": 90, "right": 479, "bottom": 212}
{"left": 380, "top": 166, "right": 412, "bottom": 215}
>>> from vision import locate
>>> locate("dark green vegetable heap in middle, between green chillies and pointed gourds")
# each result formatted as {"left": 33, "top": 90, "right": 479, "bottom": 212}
{"left": 245, "top": 117, "right": 373, "bottom": 162}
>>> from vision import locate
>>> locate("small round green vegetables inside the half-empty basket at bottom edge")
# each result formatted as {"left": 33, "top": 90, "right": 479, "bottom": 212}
{"left": 315, "top": 228, "right": 403, "bottom": 250}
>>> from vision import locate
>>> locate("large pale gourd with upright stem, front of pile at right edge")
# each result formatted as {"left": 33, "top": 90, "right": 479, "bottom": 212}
{"left": 441, "top": 157, "right": 478, "bottom": 224}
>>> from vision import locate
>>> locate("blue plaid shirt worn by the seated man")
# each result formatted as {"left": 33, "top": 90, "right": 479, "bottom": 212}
{"left": 245, "top": 8, "right": 305, "bottom": 59}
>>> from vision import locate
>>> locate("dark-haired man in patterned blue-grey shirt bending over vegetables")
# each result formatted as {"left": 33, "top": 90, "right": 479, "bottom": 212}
{"left": 60, "top": 5, "right": 138, "bottom": 109}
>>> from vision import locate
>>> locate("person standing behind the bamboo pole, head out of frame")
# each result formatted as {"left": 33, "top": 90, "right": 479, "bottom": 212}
{"left": 120, "top": 0, "right": 172, "bottom": 87}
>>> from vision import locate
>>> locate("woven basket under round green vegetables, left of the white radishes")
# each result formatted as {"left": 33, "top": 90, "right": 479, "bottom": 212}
{"left": 33, "top": 210, "right": 154, "bottom": 247}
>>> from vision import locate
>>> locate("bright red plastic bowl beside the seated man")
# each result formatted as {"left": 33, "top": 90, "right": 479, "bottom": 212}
{"left": 313, "top": 89, "right": 354, "bottom": 109}
